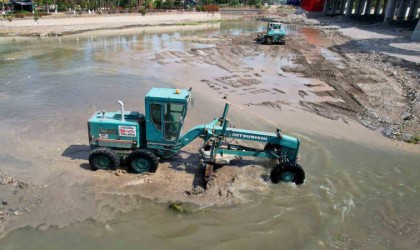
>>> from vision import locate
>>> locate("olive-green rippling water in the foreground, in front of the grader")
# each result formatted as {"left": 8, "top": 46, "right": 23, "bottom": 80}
{"left": 2, "top": 137, "right": 420, "bottom": 249}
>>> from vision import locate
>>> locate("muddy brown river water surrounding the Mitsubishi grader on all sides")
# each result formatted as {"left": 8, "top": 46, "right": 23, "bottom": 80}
{"left": 0, "top": 22, "right": 420, "bottom": 249}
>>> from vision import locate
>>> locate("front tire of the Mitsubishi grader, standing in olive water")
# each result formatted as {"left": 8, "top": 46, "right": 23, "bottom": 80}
{"left": 270, "top": 162, "right": 305, "bottom": 185}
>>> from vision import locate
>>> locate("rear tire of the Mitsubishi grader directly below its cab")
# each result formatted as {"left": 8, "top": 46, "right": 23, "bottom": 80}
{"left": 127, "top": 149, "right": 159, "bottom": 174}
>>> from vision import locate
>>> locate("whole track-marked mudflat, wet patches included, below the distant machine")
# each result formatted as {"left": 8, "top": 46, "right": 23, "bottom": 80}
{"left": 150, "top": 28, "right": 420, "bottom": 142}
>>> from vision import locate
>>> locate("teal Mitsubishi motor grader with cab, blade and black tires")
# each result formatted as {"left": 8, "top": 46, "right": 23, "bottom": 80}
{"left": 88, "top": 88, "right": 305, "bottom": 185}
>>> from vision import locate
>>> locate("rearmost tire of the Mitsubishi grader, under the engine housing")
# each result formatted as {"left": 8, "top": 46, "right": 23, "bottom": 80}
{"left": 89, "top": 148, "right": 120, "bottom": 171}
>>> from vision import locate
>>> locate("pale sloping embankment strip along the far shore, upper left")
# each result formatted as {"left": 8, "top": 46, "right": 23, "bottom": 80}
{"left": 0, "top": 12, "right": 221, "bottom": 37}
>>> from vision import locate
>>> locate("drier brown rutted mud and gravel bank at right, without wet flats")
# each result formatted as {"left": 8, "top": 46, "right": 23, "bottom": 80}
{"left": 272, "top": 29, "right": 420, "bottom": 143}
